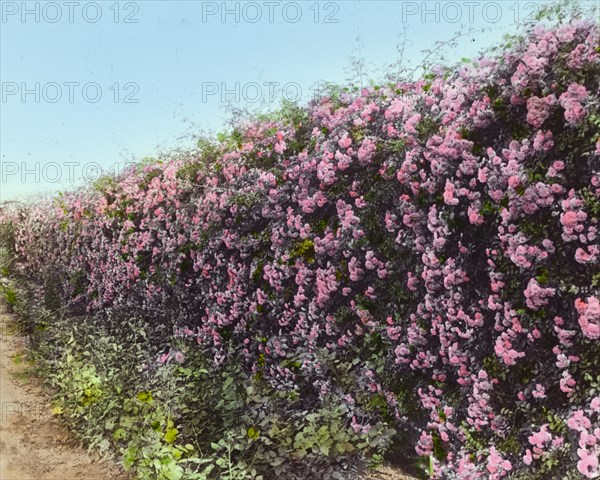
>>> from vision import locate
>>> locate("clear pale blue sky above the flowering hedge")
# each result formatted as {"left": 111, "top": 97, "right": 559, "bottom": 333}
{"left": 0, "top": 0, "right": 572, "bottom": 201}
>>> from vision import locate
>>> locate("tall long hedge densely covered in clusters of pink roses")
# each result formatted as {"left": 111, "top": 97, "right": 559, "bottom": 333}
{"left": 4, "top": 13, "right": 600, "bottom": 480}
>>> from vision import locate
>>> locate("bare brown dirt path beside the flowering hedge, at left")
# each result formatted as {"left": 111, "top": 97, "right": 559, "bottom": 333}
{"left": 0, "top": 304, "right": 127, "bottom": 480}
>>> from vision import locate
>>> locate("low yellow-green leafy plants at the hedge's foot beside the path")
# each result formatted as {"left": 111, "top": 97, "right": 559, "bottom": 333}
{"left": 21, "top": 312, "right": 395, "bottom": 480}
